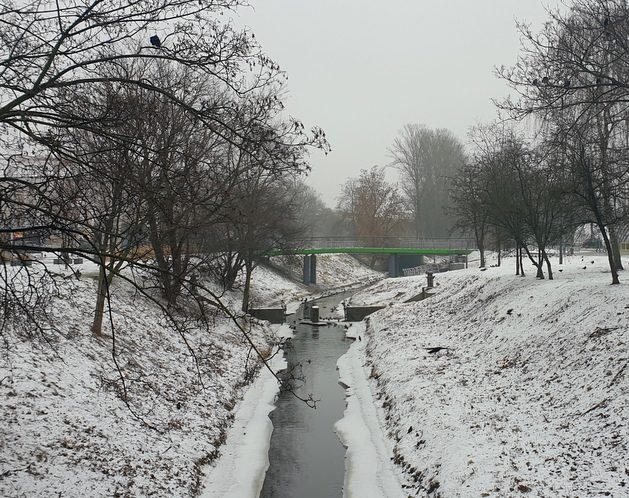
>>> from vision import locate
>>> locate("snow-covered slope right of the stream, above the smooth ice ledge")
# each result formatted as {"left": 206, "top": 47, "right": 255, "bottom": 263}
{"left": 363, "top": 255, "right": 629, "bottom": 497}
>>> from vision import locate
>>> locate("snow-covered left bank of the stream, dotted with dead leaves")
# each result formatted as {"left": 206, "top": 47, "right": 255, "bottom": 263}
{"left": 0, "top": 256, "right": 380, "bottom": 497}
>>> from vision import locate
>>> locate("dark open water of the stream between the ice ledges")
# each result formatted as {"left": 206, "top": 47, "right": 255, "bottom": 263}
{"left": 260, "top": 294, "right": 351, "bottom": 498}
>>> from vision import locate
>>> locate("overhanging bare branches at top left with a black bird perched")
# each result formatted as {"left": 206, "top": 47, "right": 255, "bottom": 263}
{"left": 0, "top": 0, "right": 332, "bottom": 163}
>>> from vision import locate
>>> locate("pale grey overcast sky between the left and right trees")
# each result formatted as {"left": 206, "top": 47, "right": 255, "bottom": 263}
{"left": 237, "top": 0, "right": 558, "bottom": 206}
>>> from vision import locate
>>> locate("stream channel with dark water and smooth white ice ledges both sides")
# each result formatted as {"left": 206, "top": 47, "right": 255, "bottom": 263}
{"left": 202, "top": 288, "right": 404, "bottom": 498}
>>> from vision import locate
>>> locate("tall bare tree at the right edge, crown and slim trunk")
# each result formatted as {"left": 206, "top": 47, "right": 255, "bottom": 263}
{"left": 498, "top": 0, "right": 629, "bottom": 283}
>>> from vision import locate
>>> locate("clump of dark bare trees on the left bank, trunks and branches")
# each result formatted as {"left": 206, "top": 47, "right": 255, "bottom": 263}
{"left": 0, "top": 0, "right": 328, "bottom": 413}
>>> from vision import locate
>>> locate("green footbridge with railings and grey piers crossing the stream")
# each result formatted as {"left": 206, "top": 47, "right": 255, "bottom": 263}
{"left": 265, "top": 237, "right": 476, "bottom": 284}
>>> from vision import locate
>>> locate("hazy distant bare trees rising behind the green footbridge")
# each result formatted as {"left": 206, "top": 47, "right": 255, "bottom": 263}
{"left": 337, "top": 124, "right": 464, "bottom": 243}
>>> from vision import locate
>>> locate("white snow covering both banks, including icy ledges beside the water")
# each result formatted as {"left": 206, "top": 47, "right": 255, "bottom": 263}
{"left": 12, "top": 249, "right": 629, "bottom": 498}
